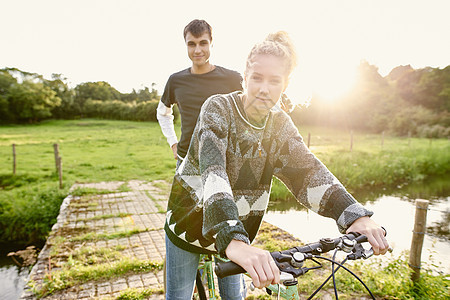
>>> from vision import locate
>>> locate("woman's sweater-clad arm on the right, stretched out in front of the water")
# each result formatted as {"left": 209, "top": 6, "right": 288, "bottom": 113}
{"left": 274, "top": 115, "right": 373, "bottom": 233}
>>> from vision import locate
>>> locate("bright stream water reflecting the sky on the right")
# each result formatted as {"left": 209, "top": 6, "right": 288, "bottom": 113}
{"left": 265, "top": 178, "right": 450, "bottom": 274}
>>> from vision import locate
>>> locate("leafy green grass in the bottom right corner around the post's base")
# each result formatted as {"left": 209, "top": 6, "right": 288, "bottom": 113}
{"left": 299, "top": 256, "right": 450, "bottom": 300}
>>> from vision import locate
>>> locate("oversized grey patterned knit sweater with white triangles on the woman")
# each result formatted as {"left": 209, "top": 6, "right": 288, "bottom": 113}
{"left": 164, "top": 92, "right": 372, "bottom": 256}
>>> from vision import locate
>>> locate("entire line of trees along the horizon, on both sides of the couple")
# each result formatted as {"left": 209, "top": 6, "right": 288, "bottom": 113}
{"left": 0, "top": 61, "right": 450, "bottom": 138}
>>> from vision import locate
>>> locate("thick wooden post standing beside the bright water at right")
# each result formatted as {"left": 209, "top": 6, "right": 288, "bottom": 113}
{"left": 409, "top": 199, "right": 429, "bottom": 282}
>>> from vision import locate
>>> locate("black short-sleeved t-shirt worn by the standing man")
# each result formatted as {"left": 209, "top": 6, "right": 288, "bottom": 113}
{"left": 161, "top": 66, "right": 242, "bottom": 157}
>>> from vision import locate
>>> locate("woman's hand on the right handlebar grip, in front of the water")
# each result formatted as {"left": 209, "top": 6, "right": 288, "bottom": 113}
{"left": 346, "top": 216, "right": 389, "bottom": 255}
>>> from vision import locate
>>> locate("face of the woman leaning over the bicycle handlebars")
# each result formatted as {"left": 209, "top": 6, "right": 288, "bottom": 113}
{"left": 244, "top": 54, "right": 288, "bottom": 120}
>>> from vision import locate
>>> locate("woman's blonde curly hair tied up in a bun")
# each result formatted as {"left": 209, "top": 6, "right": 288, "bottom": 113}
{"left": 246, "top": 31, "right": 297, "bottom": 76}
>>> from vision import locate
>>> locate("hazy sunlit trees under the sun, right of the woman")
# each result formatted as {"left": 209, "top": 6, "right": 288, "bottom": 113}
{"left": 291, "top": 61, "right": 450, "bottom": 138}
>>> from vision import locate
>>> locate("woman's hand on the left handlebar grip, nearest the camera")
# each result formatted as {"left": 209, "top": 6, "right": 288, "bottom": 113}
{"left": 225, "top": 240, "right": 280, "bottom": 288}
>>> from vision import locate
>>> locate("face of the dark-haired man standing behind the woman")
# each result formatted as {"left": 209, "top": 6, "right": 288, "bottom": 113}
{"left": 185, "top": 32, "right": 211, "bottom": 67}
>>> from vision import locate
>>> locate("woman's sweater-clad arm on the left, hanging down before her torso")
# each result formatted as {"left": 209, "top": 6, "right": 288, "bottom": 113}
{"left": 196, "top": 96, "right": 250, "bottom": 256}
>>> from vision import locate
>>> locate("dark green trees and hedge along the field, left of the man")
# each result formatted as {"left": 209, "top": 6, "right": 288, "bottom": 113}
{"left": 0, "top": 68, "right": 179, "bottom": 123}
